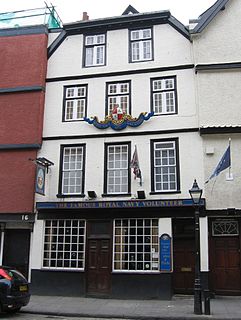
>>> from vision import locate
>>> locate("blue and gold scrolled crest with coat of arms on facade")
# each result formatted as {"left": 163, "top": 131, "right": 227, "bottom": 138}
{"left": 84, "top": 105, "right": 154, "bottom": 130}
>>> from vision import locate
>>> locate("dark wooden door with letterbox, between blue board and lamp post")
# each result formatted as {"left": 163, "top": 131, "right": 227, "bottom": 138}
{"left": 173, "top": 238, "right": 195, "bottom": 294}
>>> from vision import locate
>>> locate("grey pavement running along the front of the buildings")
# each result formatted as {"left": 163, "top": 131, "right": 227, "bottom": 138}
{"left": 21, "top": 295, "right": 241, "bottom": 320}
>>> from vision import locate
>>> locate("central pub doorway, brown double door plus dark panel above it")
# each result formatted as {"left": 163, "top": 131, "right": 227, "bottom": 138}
{"left": 87, "top": 221, "right": 112, "bottom": 296}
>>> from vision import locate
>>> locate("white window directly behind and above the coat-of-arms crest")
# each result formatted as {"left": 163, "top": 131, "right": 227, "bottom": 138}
{"left": 107, "top": 81, "right": 130, "bottom": 114}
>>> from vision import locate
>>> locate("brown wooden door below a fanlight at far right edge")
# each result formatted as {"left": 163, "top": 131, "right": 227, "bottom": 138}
{"left": 210, "top": 236, "right": 241, "bottom": 295}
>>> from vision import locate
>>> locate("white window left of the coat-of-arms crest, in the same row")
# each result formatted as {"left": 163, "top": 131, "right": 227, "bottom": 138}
{"left": 64, "top": 85, "right": 87, "bottom": 121}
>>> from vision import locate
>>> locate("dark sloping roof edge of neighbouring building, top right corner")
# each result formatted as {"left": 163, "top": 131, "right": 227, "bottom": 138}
{"left": 190, "top": 0, "right": 229, "bottom": 34}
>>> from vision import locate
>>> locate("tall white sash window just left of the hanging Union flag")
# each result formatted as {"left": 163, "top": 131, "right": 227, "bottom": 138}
{"left": 106, "top": 143, "right": 130, "bottom": 194}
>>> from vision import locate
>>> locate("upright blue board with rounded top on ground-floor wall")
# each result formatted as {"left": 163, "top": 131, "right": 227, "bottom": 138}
{"left": 160, "top": 233, "right": 172, "bottom": 272}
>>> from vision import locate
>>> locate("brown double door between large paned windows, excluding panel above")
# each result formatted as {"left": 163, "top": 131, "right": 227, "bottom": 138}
{"left": 87, "top": 239, "right": 111, "bottom": 295}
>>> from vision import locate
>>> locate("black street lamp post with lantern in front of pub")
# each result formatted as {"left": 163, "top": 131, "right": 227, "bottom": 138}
{"left": 189, "top": 179, "right": 202, "bottom": 314}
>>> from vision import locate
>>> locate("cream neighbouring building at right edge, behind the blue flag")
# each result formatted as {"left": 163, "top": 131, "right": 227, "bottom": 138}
{"left": 191, "top": 0, "right": 241, "bottom": 295}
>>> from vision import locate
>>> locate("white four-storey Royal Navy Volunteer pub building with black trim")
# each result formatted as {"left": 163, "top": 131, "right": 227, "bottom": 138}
{"left": 28, "top": 6, "right": 208, "bottom": 299}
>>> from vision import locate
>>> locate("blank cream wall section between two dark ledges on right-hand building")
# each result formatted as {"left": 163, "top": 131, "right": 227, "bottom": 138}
{"left": 197, "top": 70, "right": 241, "bottom": 127}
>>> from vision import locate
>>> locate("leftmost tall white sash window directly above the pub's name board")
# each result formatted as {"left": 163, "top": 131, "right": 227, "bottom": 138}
{"left": 61, "top": 145, "right": 85, "bottom": 195}
